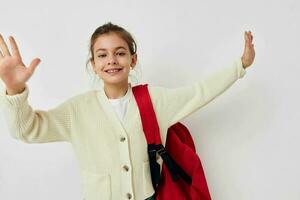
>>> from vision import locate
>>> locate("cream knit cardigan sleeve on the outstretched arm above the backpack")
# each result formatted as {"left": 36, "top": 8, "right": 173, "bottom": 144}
{"left": 164, "top": 58, "right": 246, "bottom": 127}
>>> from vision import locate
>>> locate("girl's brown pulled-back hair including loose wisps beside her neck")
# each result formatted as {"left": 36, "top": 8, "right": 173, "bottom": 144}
{"left": 86, "top": 22, "right": 139, "bottom": 87}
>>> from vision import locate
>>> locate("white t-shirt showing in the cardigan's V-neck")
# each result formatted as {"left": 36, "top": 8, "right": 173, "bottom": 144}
{"left": 108, "top": 84, "right": 132, "bottom": 122}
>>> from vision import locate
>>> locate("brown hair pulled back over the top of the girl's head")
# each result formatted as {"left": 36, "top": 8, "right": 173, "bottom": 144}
{"left": 86, "top": 22, "right": 137, "bottom": 67}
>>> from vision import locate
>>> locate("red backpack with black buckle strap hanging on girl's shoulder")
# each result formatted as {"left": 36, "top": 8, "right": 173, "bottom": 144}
{"left": 132, "top": 84, "right": 211, "bottom": 200}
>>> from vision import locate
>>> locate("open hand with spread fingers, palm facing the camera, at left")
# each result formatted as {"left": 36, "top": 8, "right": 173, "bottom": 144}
{"left": 0, "top": 34, "right": 40, "bottom": 95}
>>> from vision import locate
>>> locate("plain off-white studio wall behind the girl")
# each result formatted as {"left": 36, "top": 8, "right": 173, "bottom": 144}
{"left": 0, "top": 0, "right": 300, "bottom": 200}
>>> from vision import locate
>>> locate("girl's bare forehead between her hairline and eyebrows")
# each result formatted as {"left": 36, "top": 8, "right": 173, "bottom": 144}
{"left": 94, "top": 33, "right": 128, "bottom": 50}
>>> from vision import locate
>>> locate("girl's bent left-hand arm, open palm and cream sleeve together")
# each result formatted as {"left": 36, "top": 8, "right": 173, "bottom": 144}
{"left": 0, "top": 35, "right": 71, "bottom": 143}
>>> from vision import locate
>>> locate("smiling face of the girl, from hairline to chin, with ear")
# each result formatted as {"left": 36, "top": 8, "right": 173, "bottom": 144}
{"left": 91, "top": 33, "right": 137, "bottom": 84}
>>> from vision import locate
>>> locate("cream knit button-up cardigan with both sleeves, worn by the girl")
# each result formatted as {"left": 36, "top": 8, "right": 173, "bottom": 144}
{"left": 0, "top": 58, "right": 246, "bottom": 200}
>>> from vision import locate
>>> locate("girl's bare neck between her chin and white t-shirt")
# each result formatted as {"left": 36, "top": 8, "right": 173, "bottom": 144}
{"left": 104, "top": 82, "right": 128, "bottom": 99}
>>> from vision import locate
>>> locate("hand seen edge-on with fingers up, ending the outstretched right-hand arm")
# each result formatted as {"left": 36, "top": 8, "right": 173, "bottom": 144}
{"left": 242, "top": 31, "right": 255, "bottom": 69}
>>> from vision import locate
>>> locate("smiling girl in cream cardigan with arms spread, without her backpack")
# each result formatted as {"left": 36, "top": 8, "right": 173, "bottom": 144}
{"left": 0, "top": 23, "right": 255, "bottom": 200}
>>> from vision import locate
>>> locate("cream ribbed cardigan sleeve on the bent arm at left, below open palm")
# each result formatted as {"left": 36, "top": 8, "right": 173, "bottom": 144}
{"left": 0, "top": 85, "right": 71, "bottom": 143}
